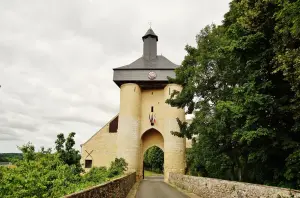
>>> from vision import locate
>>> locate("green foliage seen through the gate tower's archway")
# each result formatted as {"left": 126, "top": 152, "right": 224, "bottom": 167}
{"left": 144, "top": 146, "right": 164, "bottom": 173}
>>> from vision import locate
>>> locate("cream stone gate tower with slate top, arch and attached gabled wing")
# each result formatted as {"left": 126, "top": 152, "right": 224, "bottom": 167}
{"left": 82, "top": 29, "right": 185, "bottom": 180}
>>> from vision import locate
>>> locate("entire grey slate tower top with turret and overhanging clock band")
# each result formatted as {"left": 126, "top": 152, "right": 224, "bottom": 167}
{"left": 113, "top": 28, "right": 179, "bottom": 89}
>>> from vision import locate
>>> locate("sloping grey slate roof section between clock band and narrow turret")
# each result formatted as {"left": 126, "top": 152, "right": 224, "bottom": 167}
{"left": 114, "top": 56, "right": 179, "bottom": 70}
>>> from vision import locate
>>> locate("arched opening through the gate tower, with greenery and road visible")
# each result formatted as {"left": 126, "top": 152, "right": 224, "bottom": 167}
{"left": 143, "top": 146, "right": 164, "bottom": 178}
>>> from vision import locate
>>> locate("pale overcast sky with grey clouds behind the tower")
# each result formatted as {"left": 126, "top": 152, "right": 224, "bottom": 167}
{"left": 0, "top": 0, "right": 229, "bottom": 153}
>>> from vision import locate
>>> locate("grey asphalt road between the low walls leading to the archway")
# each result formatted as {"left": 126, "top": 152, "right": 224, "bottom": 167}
{"left": 136, "top": 176, "right": 188, "bottom": 198}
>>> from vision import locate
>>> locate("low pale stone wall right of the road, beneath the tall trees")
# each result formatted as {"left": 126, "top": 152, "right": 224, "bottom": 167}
{"left": 168, "top": 173, "right": 300, "bottom": 198}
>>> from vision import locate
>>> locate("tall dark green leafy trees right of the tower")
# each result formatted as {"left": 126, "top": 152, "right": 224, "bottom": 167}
{"left": 166, "top": 0, "right": 300, "bottom": 189}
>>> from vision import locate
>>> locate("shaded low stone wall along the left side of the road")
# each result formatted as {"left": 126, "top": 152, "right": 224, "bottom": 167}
{"left": 65, "top": 173, "right": 136, "bottom": 198}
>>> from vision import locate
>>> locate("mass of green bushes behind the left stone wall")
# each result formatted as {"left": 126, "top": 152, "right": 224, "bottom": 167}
{"left": 0, "top": 133, "right": 127, "bottom": 198}
